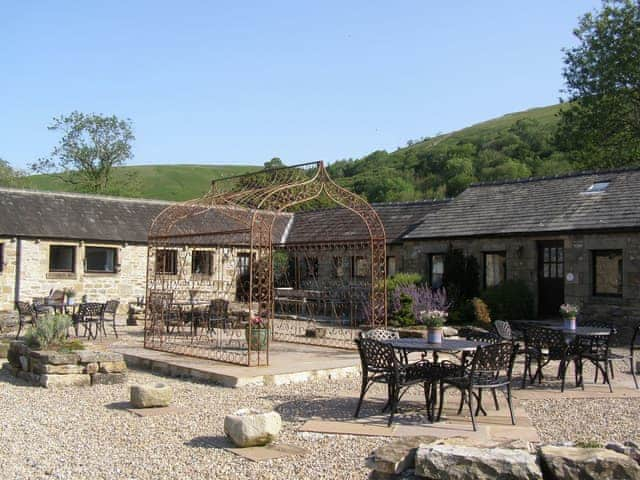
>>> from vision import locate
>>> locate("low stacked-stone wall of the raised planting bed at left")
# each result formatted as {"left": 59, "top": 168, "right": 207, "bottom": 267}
{"left": 4, "top": 341, "right": 127, "bottom": 388}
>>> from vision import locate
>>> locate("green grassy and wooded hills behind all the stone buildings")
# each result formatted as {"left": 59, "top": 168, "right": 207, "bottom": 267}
{"left": 25, "top": 105, "right": 575, "bottom": 201}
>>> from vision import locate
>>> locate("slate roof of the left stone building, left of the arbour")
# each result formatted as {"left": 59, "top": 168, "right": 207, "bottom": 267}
{"left": 0, "top": 188, "right": 170, "bottom": 243}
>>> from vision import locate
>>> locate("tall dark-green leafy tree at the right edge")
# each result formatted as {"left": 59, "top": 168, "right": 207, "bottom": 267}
{"left": 556, "top": 0, "right": 640, "bottom": 168}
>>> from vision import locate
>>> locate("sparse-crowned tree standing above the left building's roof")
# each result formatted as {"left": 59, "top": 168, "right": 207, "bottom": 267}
{"left": 31, "top": 112, "right": 135, "bottom": 193}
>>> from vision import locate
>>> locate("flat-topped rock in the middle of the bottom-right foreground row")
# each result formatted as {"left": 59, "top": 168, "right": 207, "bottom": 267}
{"left": 416, "top": 445, "right": 542, "bottom": 480}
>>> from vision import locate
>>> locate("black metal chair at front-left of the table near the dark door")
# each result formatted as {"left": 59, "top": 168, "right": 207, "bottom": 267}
{"left": 522, "top": 326, "right": 581, "bottom": 392}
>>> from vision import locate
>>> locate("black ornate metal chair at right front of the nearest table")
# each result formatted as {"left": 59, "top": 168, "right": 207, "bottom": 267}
{"left": 438, "top": 342, "right": 518, "bottom": 431}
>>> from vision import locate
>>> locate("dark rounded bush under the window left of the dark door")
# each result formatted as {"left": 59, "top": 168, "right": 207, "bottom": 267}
{"left": 480, "top": 280, "right": 534, "bottom": 320}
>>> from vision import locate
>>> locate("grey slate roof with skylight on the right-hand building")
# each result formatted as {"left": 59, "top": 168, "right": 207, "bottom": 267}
{"left": 404, "top": 168, "right": 640, "bottom": 239}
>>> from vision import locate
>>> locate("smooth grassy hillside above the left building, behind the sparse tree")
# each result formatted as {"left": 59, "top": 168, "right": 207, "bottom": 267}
{"left": 25, "top": 165, "right": 260, "bottom": 201}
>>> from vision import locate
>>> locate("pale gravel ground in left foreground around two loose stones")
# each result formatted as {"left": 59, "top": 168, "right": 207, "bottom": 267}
{"left": 0, "top": 364, "right": 388, "bottom": 480}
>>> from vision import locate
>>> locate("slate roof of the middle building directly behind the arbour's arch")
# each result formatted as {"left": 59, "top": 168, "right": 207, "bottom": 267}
{"left": 286, "top": 200, "right": 446, "bottom": 244}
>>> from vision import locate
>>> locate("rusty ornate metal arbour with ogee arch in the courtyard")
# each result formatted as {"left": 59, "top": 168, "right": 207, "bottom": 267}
{"left": 145, "top": 162, "right": 387, "bottom": 365}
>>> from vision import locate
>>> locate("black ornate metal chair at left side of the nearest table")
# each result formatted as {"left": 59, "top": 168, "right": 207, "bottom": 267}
{"left": 354, "top": 338, "right": 441, "bottom": 425}
